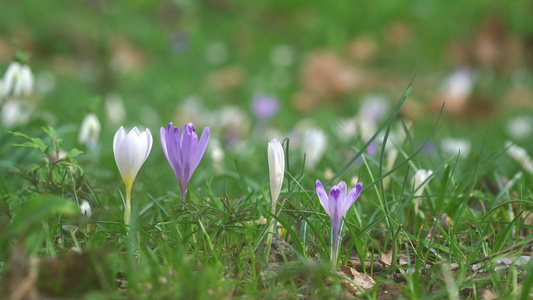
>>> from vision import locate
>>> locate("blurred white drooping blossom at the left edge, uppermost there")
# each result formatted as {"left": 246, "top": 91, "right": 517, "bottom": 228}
{"left": 1, "top": 61, "right": 35, "bottom": 98}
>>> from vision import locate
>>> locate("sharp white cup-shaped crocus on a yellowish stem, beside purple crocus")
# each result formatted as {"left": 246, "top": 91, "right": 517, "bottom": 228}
{"left": 113, "top": 126, "right": 153, "bottom": 225}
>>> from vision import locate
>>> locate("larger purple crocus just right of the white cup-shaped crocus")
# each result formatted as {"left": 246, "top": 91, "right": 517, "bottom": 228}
{"left": 161, "top": 122, "right": 211, "bottom": 202}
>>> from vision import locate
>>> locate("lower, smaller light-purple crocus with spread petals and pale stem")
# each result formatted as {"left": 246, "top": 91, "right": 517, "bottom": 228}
{"left": 316, "top": 179, "right": 363, "bottom": 266}
